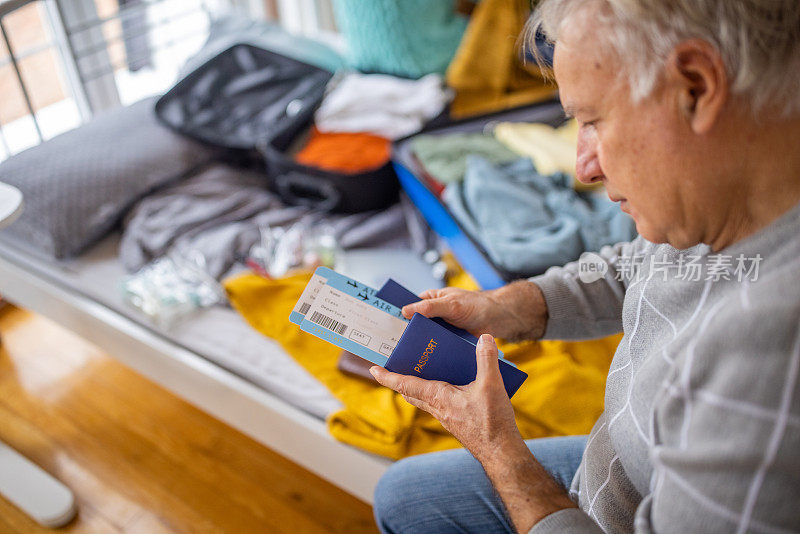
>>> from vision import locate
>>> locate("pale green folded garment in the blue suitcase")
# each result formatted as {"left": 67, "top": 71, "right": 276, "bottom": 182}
{"left": 411, "top": 133, "right": 519, "bottom": 184}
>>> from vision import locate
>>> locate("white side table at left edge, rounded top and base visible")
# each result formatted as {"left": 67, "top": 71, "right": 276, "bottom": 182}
{"left": 0, "top": 182, "right": 77, "bottom": 528}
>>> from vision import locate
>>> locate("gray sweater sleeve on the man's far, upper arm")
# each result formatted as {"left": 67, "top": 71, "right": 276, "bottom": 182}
{"left": 530, "top": 237, "right": 649, "bottom": 339}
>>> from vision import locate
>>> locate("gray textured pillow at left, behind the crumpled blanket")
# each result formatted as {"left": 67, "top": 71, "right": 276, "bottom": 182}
{"left": 0, "top": 98, "right": 217, "bottom": 258}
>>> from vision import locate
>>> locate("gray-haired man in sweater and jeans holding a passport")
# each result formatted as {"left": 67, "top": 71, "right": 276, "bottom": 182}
{"left": 372, "top": 0, "right": 800, "bottom": 533}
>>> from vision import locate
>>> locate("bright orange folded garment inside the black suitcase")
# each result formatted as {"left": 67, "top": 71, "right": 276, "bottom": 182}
{"left": 295, "top": 127, "right": 391, "bottom": 173}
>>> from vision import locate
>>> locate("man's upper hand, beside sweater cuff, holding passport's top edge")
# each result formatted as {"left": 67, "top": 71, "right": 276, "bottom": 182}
{"left": 403, "top": 280, "right": 547, "bottom": 340}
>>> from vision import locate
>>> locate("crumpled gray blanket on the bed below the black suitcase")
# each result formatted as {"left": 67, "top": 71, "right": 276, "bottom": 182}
{"left": 120, "top": 164, "right": 416, "bottom": 278}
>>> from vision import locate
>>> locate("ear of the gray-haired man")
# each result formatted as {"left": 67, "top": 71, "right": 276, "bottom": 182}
{"left": 666, "top": 39, "right": 729, "bottom": 134}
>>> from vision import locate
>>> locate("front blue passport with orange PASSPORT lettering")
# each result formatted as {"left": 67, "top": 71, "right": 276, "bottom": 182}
{"left": 384, "top": 313, "right": 528, "bottom": 398}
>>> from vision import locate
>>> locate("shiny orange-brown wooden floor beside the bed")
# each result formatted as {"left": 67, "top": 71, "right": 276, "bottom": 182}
{"left": 0, "top": 306, "right": 376, "bottom": 534}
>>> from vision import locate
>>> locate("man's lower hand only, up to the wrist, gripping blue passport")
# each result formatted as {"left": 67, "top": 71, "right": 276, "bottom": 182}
{"left": 370, "top": 334, "right": 522, "bottom": 462}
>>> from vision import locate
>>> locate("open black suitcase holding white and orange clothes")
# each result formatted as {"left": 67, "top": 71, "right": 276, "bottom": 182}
{"left": 156, "top": 44, "right": 400, "bottom": 213}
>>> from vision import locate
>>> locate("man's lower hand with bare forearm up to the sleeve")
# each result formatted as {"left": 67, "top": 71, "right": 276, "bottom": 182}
{"left": 370, "top": 334, "right": 575, "bottom": 532}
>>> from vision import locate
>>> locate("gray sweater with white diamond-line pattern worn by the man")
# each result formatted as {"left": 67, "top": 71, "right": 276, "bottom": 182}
{"left": 531, "top": 205, "right": 800, "bottom": 534}
